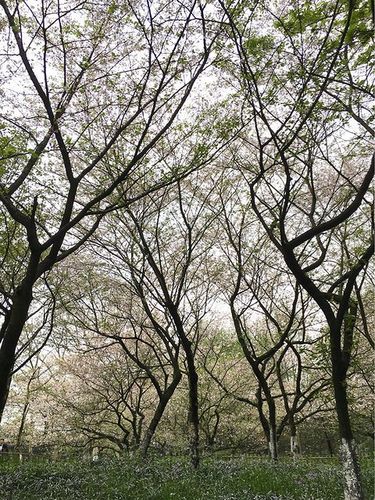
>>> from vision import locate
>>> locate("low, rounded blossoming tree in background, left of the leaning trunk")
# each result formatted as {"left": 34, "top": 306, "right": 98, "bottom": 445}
{"left": 48, "top": 346, "right": 155, "bottom": 454}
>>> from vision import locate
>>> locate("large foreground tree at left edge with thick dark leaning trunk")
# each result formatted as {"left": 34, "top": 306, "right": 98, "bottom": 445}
{"left": 0, "top": 0, "right": 226, "bottom": 416}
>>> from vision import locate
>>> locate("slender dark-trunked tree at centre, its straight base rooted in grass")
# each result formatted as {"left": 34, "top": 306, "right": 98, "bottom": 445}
{"left": 113, "top": 176, "right": 219, "bottom": 468}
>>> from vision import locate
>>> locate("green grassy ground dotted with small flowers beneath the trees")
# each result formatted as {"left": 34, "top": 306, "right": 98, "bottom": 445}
{"left": 0, "top": 457, "right": 374, "bottom": 500}
